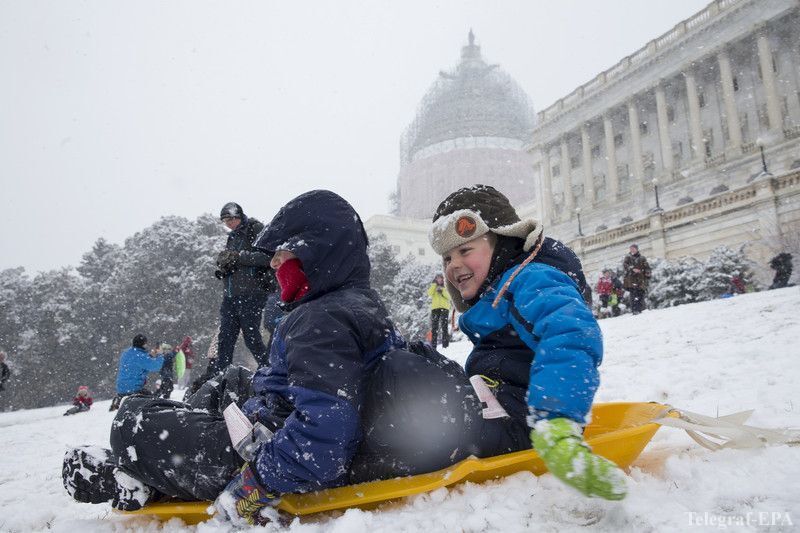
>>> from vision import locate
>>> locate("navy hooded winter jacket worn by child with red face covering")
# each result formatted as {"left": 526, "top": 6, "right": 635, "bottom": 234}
{"left": 244, "top": 191, "right": 403, "bottom": 493}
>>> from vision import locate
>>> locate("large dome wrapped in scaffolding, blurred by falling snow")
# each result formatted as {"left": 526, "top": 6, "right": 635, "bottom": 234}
{"left": 398, "top": 30, "right": 535, "bottom": 218}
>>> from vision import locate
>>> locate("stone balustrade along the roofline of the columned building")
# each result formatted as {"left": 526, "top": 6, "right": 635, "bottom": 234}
{"left": 537, "top": 0, "right": 744, "bottom": 124}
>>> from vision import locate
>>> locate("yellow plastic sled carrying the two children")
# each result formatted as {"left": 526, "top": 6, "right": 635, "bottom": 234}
{"left": 119, "top": 402, "right": 670, "bottom": 524}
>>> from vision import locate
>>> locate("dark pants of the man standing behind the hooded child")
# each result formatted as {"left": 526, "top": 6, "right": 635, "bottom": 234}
{"left": 214, "top": 294, "right": 269, "bottom": 372}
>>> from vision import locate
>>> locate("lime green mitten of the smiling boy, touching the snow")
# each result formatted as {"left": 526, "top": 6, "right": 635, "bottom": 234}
{"left": 531, "top": 418, "right": 627, "bottom": 500}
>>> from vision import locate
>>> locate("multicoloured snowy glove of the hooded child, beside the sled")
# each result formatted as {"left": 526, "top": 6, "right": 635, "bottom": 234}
{"left": 214, "top": 463, "right": 278, "bottom": 526}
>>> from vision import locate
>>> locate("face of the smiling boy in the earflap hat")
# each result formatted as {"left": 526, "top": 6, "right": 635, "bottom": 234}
{"left": 442, "top": 234, "right": 494, "bottom": 300}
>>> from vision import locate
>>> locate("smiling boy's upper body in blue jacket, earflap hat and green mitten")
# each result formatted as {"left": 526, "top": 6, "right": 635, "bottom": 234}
{"left": 429, "top": 185, "right": 626, "bottom": 500}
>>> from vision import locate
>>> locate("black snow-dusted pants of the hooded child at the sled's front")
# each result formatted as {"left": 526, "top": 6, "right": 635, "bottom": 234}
{"left": 111, "top": 367, "right": 252, "bottom": 501}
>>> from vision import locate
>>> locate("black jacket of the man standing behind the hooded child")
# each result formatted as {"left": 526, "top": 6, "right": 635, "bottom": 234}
{"left": 223, "top": 216, "right": 275, "bottom": 298}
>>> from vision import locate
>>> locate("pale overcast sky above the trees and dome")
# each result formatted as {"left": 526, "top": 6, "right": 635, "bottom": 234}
{"left": 0, "top": 0, "right": 707, "bottom": 271}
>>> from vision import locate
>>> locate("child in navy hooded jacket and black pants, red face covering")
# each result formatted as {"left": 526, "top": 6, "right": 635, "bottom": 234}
{"left": 62, "top": 191, "right": 416, "bottom": 523}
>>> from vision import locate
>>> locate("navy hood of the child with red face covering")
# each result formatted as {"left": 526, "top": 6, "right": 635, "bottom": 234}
{"left": 255, "top": 190, "right": 370, "bottom": 301}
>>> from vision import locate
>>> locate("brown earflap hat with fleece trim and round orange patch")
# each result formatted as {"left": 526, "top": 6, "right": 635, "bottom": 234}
{"left": 428, "top": 185, "right": 542, "bottom": 255}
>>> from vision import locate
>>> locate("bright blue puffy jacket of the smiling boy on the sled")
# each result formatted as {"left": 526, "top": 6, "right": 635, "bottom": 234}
{"left": 459, "top": 262, "right": 603, "bottom": 425}
